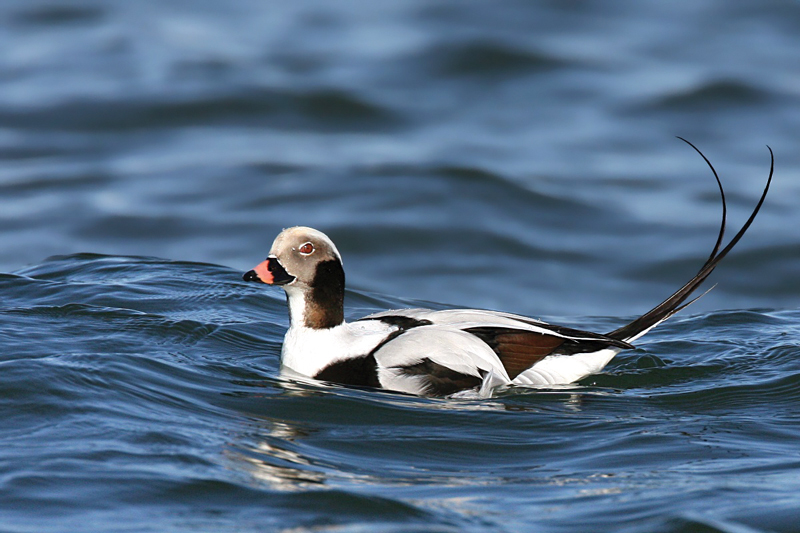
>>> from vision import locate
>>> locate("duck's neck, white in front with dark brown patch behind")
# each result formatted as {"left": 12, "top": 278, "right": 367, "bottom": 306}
{"left": 285, "top": 260, "right": 344, "bottom": 329}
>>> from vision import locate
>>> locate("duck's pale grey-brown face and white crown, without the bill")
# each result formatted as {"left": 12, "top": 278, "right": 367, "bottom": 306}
{"left": 270, "top": 226, "right": 342, "bottom": 285}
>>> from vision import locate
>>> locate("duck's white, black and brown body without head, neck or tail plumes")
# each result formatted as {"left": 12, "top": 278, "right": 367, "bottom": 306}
{"left": 282, "top": 309, "right": 632, "bottom": 396}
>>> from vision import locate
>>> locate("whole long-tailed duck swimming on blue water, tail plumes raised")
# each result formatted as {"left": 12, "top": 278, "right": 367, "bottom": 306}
{"left": 244, "top": 141, "right": 774, "bottom": 397}
